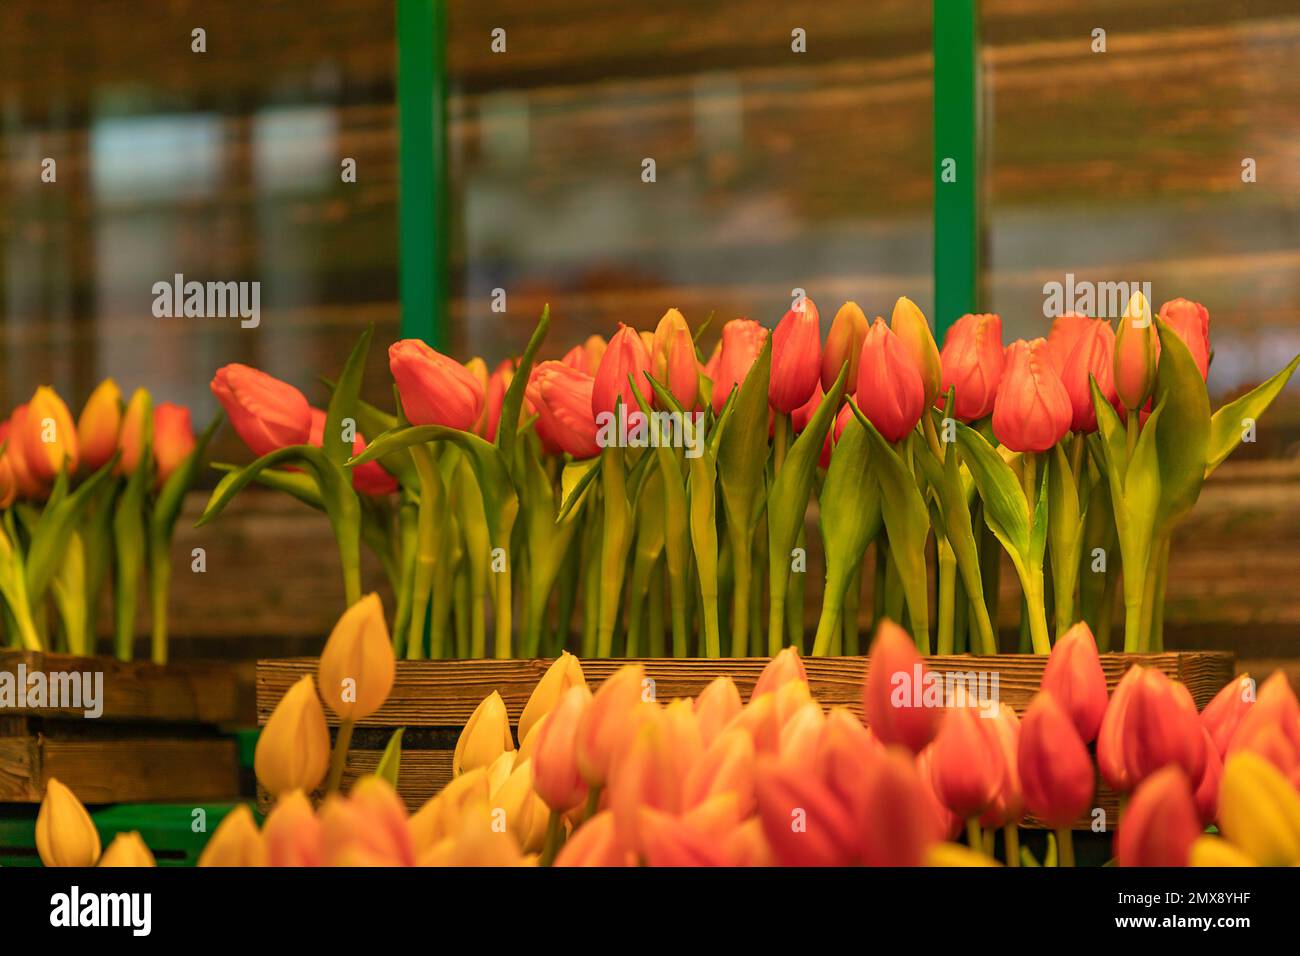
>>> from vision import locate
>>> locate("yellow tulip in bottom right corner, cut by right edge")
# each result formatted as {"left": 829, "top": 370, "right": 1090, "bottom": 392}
{"left": 1219, "top": 753, "right": 1300, "bottom": 866}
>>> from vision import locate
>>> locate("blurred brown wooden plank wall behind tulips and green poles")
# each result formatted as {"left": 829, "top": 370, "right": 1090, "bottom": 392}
{"left": 0, "top": 0, "right": 1300, "bottom": 671}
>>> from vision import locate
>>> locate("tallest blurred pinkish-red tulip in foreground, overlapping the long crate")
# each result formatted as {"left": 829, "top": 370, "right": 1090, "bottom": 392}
{"left": 862, "top": 620, "right": 943, "bottom": 753}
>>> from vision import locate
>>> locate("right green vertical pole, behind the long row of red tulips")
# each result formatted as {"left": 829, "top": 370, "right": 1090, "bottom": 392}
{"left": 933, "top": 0, "right": 980, "bottom": 342}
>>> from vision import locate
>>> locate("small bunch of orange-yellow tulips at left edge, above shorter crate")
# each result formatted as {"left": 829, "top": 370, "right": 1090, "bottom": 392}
{"left": 0, "top": 378, "right": 217, "bottom": 663}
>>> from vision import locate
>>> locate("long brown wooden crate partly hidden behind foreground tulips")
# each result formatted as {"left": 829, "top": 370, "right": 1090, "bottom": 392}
{"left": 257, "top": 650, "right": 1234, "bottom": 819}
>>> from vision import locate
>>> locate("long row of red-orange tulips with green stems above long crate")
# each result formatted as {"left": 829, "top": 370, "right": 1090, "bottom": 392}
{"left": 204, "top": 294, "right": 1300, "bottom": 658}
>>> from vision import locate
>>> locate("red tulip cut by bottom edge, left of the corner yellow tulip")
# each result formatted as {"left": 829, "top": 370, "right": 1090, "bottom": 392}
{"left": 1115, "top": 763, "right": 1203, "bottom": 866}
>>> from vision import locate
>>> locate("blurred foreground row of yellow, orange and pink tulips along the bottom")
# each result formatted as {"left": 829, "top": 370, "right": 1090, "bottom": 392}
{"left": 38, "top": 596, "right": 1300, "bottom": 866}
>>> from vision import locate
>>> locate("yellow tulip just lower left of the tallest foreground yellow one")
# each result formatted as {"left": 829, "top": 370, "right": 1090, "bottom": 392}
{"left": 254, "top": 674, "right": 329, "bottom": 797}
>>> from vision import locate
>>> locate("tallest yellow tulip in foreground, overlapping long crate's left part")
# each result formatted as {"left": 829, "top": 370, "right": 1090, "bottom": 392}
{"left": 317, "top": 593, "right": 397, "bottom": 721}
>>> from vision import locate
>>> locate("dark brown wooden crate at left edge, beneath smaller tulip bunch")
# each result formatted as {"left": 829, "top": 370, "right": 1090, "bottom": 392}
{"left": 0, "top": 652, "right": 251, "bottom": 804}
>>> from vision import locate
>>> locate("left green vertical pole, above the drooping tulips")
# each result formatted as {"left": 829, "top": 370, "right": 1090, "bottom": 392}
{"left": 398, "top": 0, "right": 449, "bottom": 351}
